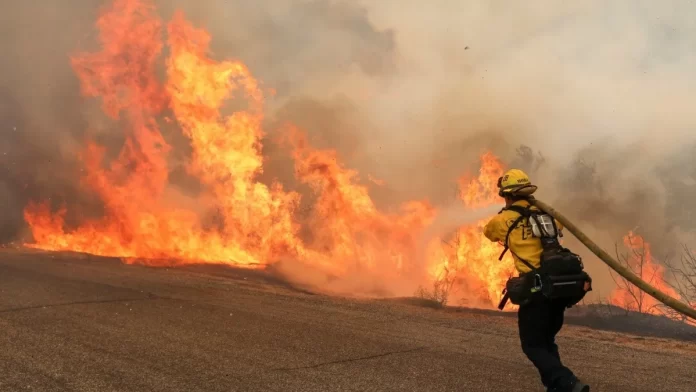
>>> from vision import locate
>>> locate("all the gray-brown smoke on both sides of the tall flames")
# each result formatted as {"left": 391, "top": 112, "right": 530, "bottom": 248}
{"left": 0, "top": 0, "right": 696, "bottom": 300}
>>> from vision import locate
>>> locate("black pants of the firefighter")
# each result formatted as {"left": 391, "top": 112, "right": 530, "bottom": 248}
{"left": 517, "top": 296, "right": 576, "bottom": 390}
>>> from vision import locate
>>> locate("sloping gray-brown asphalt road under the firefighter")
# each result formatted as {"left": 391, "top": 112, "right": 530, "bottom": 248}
{"left": 0, "top": 251, "right": 696, "bottom": 392}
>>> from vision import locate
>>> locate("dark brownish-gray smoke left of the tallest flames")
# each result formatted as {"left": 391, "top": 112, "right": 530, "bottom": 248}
{"left": 0, "top": 1, "right": 96, "bottom": 243}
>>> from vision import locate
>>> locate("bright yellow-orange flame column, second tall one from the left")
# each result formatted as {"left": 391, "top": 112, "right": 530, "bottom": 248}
{"left": 167, "top": 13, "right": 300, "bottom": 263}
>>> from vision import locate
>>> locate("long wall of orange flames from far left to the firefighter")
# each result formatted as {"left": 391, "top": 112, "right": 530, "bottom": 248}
{"left": 25, "top": 0, "right": 513, "bottom": 306}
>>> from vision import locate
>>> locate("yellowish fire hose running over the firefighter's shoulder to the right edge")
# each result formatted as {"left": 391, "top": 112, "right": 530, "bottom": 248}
{"left": 531, "top": 199, "right": 696, "bottom": 320}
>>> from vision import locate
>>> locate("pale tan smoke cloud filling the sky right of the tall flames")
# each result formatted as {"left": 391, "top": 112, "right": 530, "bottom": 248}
{"left": 181, "top": 0, "right": 696, "bottom": 273}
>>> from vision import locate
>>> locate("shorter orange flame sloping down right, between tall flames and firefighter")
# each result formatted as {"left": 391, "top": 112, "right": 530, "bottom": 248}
{"left": 282, "top": 128, "right": 435, "bottom": 278}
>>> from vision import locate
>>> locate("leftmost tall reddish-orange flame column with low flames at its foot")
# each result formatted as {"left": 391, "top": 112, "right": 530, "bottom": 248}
{"left": 25, "top": 0, "right": 177, "bottom": 264}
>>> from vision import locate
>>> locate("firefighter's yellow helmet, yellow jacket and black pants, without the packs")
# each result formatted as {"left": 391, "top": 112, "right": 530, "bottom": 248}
{"left": 484, "top": 169, "right": 590, "bottom": 392}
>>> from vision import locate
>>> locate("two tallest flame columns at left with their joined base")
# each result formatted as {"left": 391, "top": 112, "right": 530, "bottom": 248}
{"left": 25, "top": 0, "right": 298, "bottom": 265}
